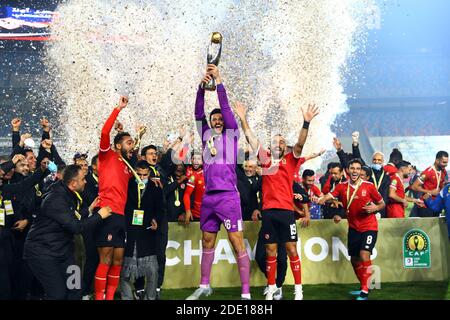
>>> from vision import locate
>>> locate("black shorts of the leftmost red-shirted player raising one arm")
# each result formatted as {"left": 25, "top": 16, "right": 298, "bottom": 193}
{"left": 94, "top": 209, "right": 126, "bottom": 248}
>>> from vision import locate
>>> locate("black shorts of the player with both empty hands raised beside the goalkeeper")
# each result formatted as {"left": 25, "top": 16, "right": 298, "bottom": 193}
{"left": 261, "top": 209, "right": 298, "bottom": 244}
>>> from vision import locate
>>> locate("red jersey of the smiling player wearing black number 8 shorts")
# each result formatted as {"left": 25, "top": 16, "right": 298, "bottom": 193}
{"left": 330, "top": 181, "right": 383, "bottom": 232}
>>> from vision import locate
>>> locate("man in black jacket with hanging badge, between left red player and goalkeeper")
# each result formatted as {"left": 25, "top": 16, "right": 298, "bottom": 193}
{"left": 120, "top": 160, "right": 164, "bottom": 300}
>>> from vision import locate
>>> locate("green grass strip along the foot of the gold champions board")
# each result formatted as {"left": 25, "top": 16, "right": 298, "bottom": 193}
{"left": 161, "top": 282, "right": 450, "bottom": 300}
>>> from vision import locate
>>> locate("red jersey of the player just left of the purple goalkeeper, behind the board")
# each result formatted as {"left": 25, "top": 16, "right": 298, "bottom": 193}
{"left": 183, "top": 168, "right": 205, "bottom": 218}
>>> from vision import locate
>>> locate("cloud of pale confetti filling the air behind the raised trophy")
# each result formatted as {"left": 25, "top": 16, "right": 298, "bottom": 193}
{"left": 39, "top": 0, "right": 376, "bottom": 167}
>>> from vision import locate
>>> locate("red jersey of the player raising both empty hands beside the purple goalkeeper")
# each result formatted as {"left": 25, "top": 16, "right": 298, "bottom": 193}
{"left": 258, "top": 147, "right": 300, "bottom": 211}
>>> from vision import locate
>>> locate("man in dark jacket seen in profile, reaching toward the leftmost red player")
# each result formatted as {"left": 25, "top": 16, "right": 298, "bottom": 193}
{"left": 24, "top": 165, "right": 111, "bottom": 300}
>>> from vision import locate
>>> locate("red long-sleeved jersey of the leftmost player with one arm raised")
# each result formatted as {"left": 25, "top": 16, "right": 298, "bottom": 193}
{"left": 97, "top": 108, "right": 132, "bottom": 215}
